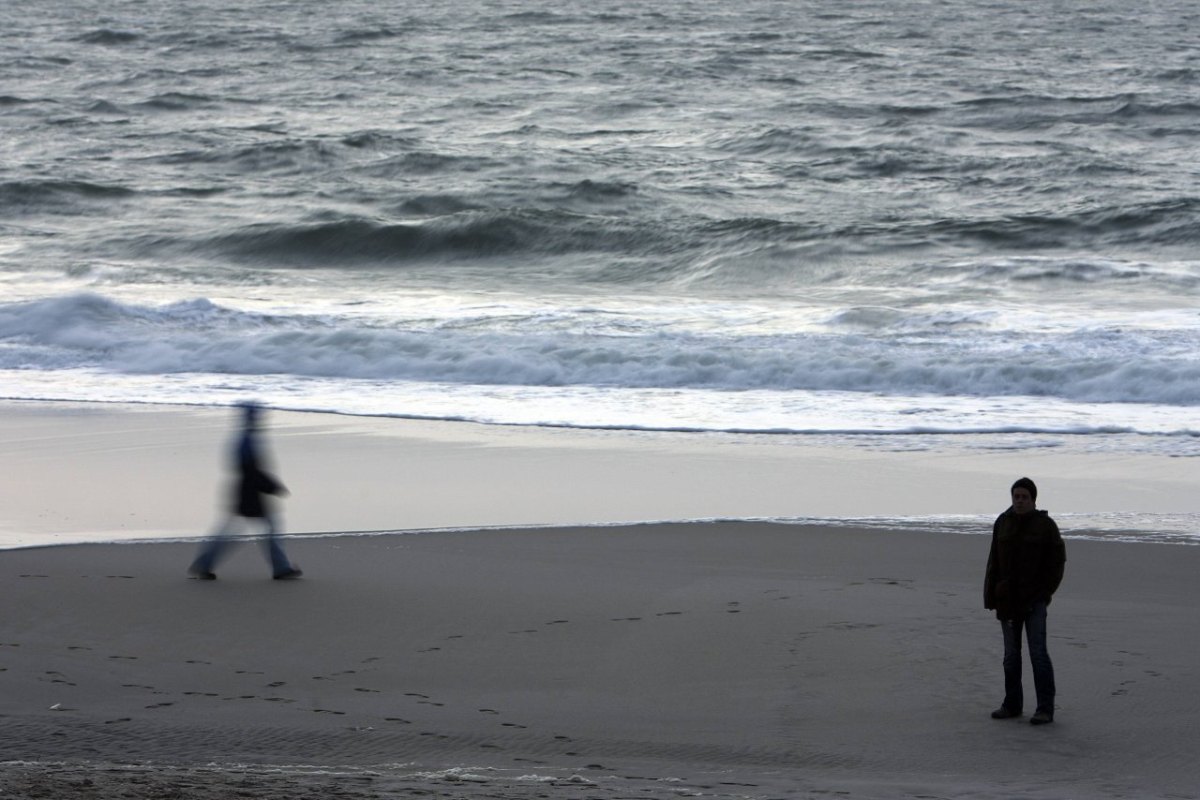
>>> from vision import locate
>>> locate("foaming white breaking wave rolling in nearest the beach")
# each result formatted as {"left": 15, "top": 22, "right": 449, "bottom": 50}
{"left": 0, "top": 294, "right": 1200, "bottom": 407}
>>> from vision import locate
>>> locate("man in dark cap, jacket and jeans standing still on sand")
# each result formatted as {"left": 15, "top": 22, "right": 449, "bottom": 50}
{"left": 983, "top": 477, "right": 1067, "bottom": 724}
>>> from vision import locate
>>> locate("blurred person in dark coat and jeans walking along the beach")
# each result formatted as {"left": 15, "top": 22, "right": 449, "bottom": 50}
{"left": 187, "top": 403, "right": 300, "bottom": 581}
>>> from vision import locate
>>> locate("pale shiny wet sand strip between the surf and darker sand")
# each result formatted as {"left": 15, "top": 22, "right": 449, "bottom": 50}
{"left": 0, "top": 401, "right": 1198, "bottom": 548}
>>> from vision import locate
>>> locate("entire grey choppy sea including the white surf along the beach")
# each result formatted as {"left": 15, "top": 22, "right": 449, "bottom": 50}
{"left": 0, "top": 0, "right": 1200, "bottom": 457}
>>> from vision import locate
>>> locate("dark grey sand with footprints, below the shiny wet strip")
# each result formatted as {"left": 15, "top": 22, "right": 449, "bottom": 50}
{"left": 0, "top": 523, "right": 1200, "bottom": 799}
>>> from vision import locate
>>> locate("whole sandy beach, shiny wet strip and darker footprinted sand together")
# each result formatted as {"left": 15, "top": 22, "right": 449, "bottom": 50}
{"left": 0, "top": 403, "right": 1200, "bottom": 800}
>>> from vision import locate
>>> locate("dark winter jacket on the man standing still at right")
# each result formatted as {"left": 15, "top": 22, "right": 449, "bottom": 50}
{"left": 983, "top": 509, "right": 1067, "bottom": 619}
